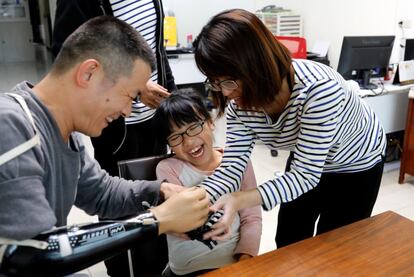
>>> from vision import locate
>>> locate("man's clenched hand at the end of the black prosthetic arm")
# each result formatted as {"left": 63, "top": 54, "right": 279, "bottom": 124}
{"left": 151, "top": 187, "right": 210, "bottom": 234}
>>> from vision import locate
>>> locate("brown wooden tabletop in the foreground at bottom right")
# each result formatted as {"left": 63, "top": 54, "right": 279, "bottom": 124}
{"left": 203, "top": 211, "right": 414, "bottom": 277}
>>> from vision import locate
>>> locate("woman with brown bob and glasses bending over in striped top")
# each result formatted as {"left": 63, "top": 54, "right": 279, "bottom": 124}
{"left": 194, "top": 9, "right": 386, "bottom": 247}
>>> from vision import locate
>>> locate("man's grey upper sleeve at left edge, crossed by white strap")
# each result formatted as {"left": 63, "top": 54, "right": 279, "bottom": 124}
{"left": 0, "top": 108, "right": 56, "bottom": 240}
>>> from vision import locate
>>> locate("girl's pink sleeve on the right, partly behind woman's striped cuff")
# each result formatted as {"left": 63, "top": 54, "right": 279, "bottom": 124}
{"left": 234, "top": 161, "right": 262, "bottom": 256}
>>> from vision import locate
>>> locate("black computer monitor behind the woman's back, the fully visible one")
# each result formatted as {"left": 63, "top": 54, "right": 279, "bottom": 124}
{"left": 338, "top": 36, "right": 395, "bottom": 89}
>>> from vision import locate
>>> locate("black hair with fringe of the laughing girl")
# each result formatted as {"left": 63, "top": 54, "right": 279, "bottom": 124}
{"left": 154, "top": 88, "right": 211, "bottom": 141}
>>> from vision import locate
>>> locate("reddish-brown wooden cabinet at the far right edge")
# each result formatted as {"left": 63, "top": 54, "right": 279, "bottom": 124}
{"left": 398, "top": 89, "right": 414, "bottom": 184}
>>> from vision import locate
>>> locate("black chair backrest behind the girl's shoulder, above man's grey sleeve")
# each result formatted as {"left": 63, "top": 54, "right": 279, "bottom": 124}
{"left": 118, "top": 154, "right": 173, "bottom": 181}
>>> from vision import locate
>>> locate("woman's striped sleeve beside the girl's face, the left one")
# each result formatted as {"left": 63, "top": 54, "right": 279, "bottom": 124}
{"left": 202, "top": 104, "right": 256, "bottom": 202}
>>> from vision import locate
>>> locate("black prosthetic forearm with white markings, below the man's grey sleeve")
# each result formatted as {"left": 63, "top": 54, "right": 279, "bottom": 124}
{"left": 0, "top": 212, "right": 158, "bottom": 276}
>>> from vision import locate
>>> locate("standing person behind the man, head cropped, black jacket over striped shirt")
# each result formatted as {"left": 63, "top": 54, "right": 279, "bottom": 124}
{"left": 52, "top": 0, "right": 177, "bottom": 176}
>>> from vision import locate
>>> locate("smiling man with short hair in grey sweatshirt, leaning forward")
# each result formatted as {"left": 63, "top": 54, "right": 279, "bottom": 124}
{"left": 0, "top": 16, "right": 209, "bottom": 246}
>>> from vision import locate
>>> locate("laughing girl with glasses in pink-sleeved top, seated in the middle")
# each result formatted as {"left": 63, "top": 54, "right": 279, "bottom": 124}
{"left": 155, "top": 90, "right": 261, "bottom": 276}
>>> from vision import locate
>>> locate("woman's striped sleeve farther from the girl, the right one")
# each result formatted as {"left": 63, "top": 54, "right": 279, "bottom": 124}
{"left": 258, "top": 80, "right": 345, "bottom": 210}
